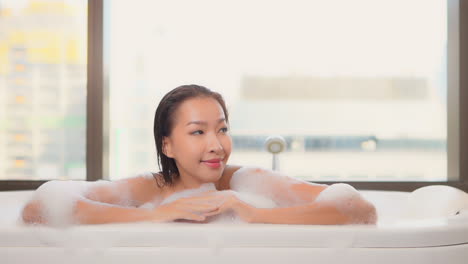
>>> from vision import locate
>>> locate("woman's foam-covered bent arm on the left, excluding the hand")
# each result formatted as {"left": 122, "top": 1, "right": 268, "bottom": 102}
{"left": 22, "top": 175, "right": 158, "bottom": 225}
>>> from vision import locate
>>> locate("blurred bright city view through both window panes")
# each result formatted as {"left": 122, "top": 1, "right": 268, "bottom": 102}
{"left": 0, "top": 0, "right": 454, "bottom": 181}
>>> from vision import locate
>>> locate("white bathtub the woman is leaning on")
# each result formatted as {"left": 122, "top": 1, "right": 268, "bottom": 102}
{"left": 0, "top": 191, "right": 468, "bottom": 264}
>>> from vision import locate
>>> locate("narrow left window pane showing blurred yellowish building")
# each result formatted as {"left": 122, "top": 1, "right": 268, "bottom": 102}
{"left": 0, "top": 0, "right": 87, "bottom": 180}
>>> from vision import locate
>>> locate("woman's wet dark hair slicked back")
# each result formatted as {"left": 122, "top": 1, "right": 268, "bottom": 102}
{"left": 153, "top": 84, "right": 229, "bottom": 187}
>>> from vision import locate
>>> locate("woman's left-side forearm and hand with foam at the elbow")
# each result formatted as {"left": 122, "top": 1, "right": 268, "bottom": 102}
{"left": 22, "top": 177, "right": 225, "bottom": 226}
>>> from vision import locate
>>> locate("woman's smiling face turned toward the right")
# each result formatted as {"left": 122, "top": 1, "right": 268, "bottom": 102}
{"left": 163, "top": 97, "right": 232, "bottom": 188}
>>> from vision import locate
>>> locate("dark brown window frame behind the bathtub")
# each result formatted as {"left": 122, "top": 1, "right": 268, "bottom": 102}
{"left": 0, "top": 0, "right": 468, "bottom": 192}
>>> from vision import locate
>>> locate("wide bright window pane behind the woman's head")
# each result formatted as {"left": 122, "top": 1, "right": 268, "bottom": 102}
{"left": 106, "top": 0, "right": 447, "bottom": 181}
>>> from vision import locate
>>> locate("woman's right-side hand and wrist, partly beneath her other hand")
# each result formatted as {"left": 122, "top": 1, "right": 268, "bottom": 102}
{"left": 206, "top": 191, "right": 259, "bottom": 223}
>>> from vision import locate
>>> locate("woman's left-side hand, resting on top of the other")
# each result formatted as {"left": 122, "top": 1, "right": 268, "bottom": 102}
{"left": 153, "top": 191, "right": 222, "bottom": 222}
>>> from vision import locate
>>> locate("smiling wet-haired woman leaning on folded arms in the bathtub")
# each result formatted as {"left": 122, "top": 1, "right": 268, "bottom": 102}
{"left": 22, "top": 85, "right": 377, "bottom": 224}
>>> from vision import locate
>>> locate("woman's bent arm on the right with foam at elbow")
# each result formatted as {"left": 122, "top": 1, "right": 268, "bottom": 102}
{"left": 219, "top": 166, "right": 377, "bottom": 225}
